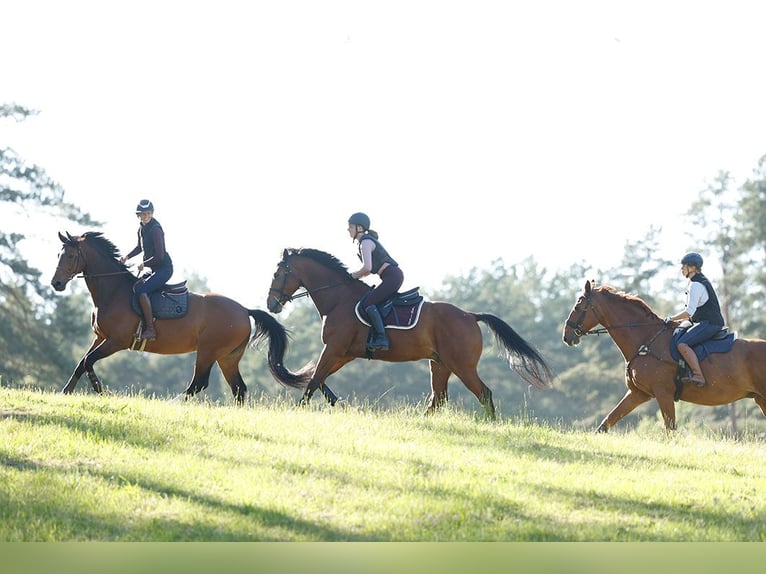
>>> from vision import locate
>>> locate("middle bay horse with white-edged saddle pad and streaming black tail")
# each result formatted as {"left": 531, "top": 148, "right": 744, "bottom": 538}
{"left": 266, "top": 248, "right": 552, "bottom": 419}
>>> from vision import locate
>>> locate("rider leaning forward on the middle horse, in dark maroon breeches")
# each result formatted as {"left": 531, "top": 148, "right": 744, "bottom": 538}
{"left": 348, "top": 213, "right": 404, "bottom": 351}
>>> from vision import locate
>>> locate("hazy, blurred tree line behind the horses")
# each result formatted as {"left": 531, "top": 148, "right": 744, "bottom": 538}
{"left": 0, "top": 104, "right": 766, "bottom": 433}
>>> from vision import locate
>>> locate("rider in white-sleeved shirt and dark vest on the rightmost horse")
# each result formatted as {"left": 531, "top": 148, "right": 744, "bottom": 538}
{"left": 665, "top": 253, "right": 724, "bottom": 387}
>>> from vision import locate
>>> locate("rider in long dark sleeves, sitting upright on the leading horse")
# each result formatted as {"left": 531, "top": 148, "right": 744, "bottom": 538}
{"left": 120, "top": 199, "right": 173, "bottom": 341}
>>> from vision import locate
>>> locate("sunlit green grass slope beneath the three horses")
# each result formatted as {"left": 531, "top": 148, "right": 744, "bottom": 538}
{"left": 0, "top": 389, "right": 766, "bottom": 542}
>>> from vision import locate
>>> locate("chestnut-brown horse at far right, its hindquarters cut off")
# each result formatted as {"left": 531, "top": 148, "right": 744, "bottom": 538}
{"left": 563, "top": 281, "right": 766, "bottom": 432}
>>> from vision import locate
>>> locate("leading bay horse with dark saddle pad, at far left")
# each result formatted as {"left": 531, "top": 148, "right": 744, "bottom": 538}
{"left": 51, "top": 231, "right": 309, "bottom": 404}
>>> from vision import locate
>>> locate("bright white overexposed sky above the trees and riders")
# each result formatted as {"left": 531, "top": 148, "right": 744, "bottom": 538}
{"left": 0, "top": 0, "right": 766, "bottom": 308}
